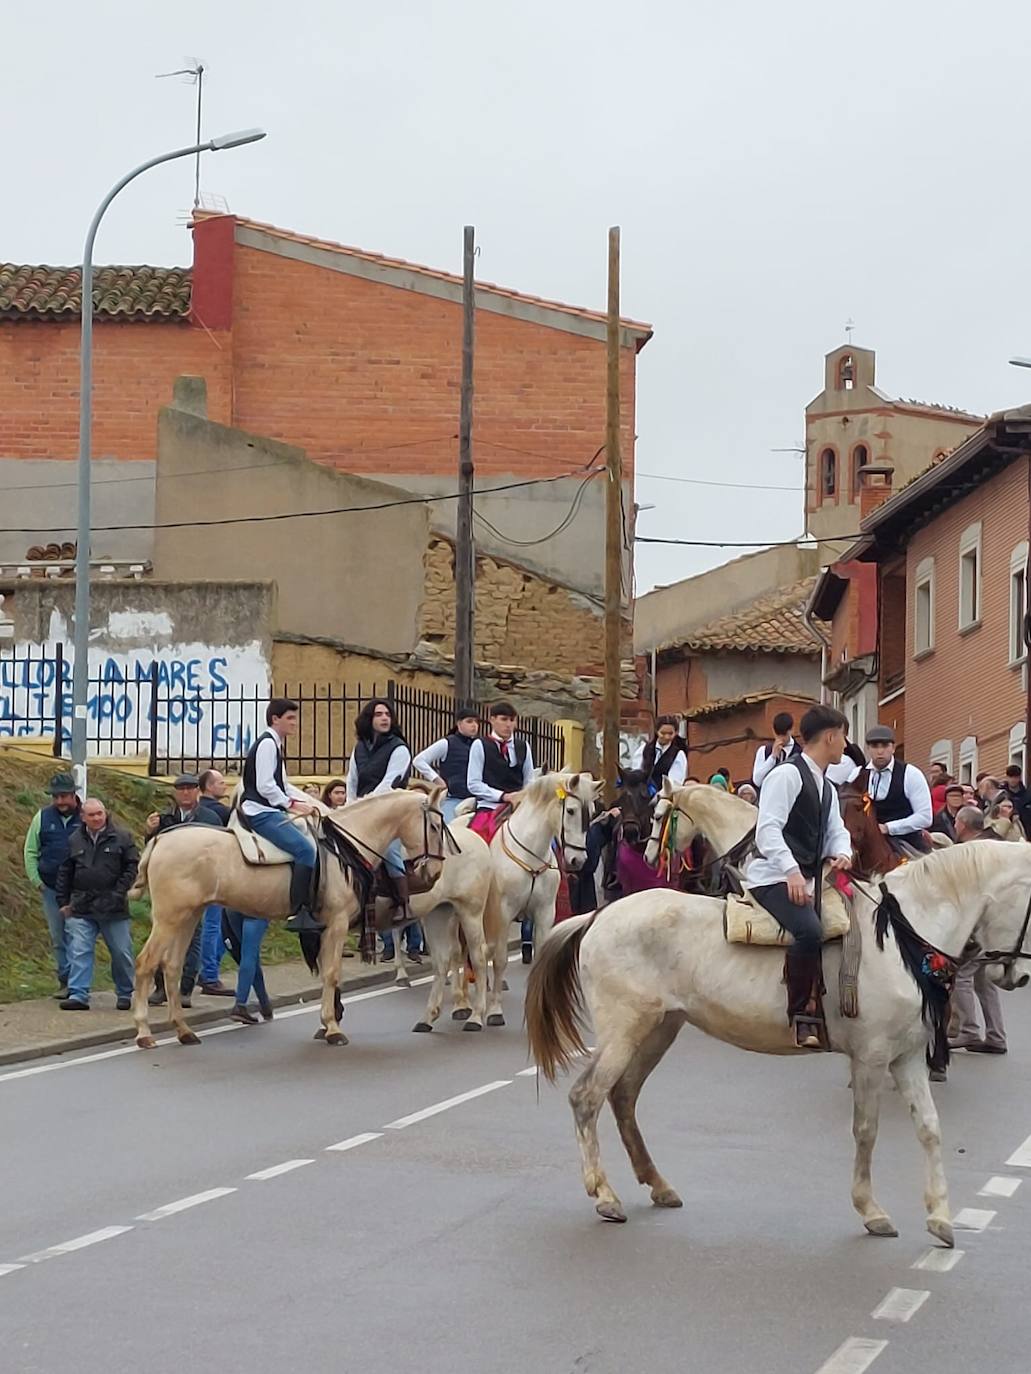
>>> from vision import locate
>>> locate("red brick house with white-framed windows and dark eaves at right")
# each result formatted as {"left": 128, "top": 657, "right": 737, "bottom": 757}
{"left": 811, "top": 408, "right": 1031, "bottom": 780}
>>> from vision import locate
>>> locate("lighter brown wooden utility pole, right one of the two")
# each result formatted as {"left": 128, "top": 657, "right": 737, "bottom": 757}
{"left": 602, "top": 228, "right": 623, "bottom": 805}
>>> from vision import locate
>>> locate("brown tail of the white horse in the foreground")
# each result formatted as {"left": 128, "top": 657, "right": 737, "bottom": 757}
{"left": 525, "top": 911, "right": 598, "bottom": 1083}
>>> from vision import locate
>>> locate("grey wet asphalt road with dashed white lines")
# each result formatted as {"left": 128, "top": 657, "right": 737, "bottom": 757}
{"left": 0, "top": 970, "right": 1031, "bottom": 1374}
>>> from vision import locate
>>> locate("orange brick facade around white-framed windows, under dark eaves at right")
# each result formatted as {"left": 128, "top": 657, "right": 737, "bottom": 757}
{"left": 905, "top": 458, "right": 1028, "bottom": 772}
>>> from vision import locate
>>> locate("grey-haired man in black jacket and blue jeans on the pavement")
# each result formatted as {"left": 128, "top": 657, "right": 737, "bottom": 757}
{"left": 56, "top": 797, "right": 139, "bottom": 1011}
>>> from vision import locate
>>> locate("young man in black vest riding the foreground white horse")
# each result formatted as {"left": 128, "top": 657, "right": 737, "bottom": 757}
{"left": 745, "top": 706, "right": 852, "bottom": 1050}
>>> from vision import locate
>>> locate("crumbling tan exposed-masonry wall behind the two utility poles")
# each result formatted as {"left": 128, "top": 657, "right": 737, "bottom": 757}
{"left": 419, "top": 539, "right": 605, "bottom": 675}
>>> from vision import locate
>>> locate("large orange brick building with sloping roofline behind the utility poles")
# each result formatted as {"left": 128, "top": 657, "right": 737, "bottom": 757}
{"left": 0, "top": 214, "right": 652, "bottom": 592}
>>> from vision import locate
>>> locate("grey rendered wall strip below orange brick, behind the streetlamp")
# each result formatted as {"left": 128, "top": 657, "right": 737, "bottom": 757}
{"left": 0, "top": 456, "right": 154, "bottom": 563}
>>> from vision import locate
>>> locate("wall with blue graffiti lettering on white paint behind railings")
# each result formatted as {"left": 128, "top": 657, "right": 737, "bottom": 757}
{"left": 0, "top": 580, "right": 274, "bottom": 758}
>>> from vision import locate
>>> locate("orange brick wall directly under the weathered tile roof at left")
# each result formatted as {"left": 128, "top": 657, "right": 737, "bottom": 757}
{"left": 0, "top": 319, "right": 232, "bottom": 459}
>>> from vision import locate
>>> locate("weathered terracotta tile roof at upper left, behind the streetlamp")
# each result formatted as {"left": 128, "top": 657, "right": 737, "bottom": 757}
{"left": 0, "top": 262, "right": 191, "bottom": 320}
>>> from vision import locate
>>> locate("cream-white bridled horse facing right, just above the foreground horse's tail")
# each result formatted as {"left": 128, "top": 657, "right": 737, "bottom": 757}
{"left": 484, "top": 772, "right": 601, "bottom": 1026}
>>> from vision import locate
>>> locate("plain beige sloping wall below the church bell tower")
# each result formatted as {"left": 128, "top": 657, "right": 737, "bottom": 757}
{"left": 634, "top": 544, "right": 819, "bottom": 654}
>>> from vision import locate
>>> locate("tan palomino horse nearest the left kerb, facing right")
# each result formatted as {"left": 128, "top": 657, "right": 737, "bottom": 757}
{"left": 131, "top": 783, "right": 444, "bottom": 1050}
